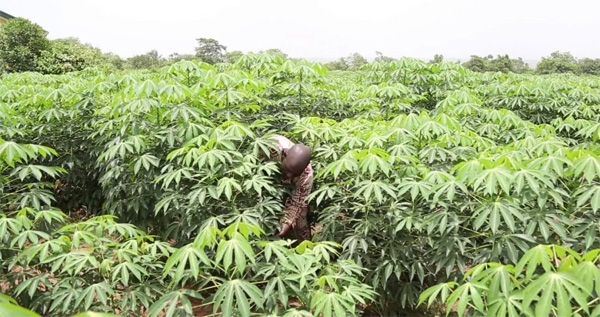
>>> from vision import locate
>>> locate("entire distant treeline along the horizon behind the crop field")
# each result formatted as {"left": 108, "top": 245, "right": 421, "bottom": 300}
{"left": 0, "top": 18, "right": 600, "bottom": 76}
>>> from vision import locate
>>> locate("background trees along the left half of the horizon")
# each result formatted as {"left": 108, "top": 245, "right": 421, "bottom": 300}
{"left": 0, "top": 18, "right": 258, "bottom": 74}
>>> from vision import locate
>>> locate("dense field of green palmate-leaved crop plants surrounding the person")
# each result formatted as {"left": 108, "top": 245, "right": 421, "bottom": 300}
{"left": 0, "top": 54, "right": 600, "bottom": 316}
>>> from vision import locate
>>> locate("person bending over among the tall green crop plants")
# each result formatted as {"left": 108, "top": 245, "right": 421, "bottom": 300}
{"left": 271, "top": 135, "right": 313, "bottom": 241}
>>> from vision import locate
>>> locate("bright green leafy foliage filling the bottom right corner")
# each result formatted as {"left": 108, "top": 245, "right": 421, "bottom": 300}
{"left": 419, "top": 245, "right": 600, "bottom": 316}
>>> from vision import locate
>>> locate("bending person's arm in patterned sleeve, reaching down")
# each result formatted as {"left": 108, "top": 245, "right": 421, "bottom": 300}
{"left": 278, "top": 165, "right": 313, "bottom": 237}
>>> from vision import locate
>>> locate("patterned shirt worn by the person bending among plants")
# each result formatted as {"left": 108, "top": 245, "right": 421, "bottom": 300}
{"left": 271, "top": 135, "right": 314, "bottom": 227}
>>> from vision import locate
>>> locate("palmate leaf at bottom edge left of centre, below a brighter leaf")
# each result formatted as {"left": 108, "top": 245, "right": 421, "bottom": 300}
{"left": 213, "top": 279, "right": 264, "bottom": 317}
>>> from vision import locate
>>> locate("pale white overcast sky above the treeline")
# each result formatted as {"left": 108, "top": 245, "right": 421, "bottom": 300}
{"left": 0, "top": 0, "right": 600, "bottom": 60}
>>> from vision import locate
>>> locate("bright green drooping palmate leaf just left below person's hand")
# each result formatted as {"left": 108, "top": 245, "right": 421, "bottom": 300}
{"left": 215, "top": 232, "right": 255, "bottom": 275}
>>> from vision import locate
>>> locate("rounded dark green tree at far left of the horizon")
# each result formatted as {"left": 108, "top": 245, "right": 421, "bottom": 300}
{"left": 0, "top": 18, "right": 50, "bottom": 72}
